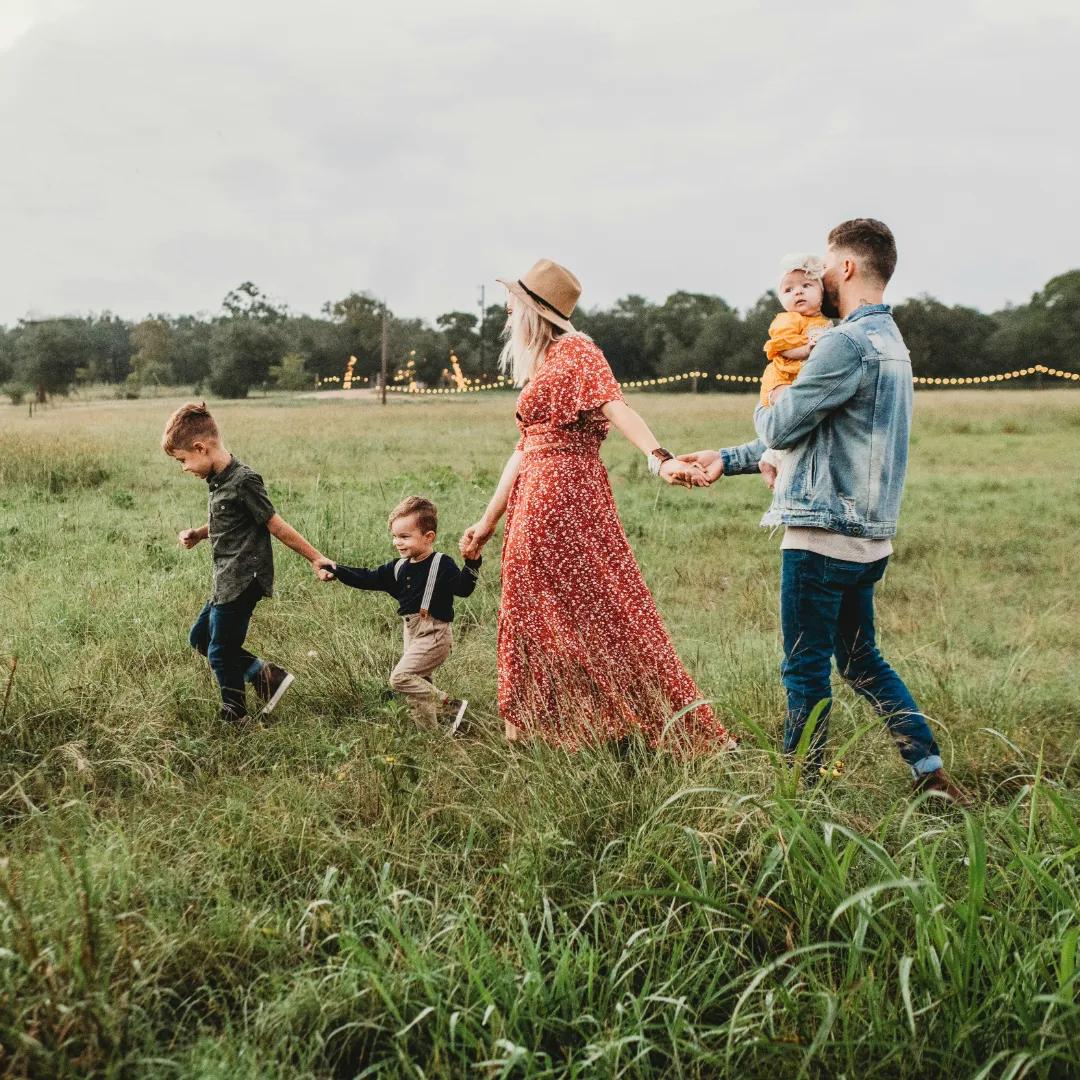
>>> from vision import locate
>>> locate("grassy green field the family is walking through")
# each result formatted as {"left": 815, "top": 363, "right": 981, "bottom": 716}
{"left": 0, "top": 390, "right": 1080, "bottom": 1080}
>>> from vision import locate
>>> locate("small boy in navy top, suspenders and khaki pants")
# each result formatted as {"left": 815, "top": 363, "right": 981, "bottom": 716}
{"left": 320, "top": 496, "right": 483, "bottom": 734}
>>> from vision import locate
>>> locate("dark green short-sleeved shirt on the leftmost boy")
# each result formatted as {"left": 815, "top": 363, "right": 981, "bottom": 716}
{"left": 206, "top": 458, "right": 274, "bottom": 604}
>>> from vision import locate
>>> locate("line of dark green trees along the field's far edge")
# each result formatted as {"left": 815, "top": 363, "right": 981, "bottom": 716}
{"left": 0, "top": 270, "right": 1080, "bottom": 402}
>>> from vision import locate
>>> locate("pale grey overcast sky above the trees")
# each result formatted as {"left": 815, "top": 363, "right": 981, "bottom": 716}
{"left": 0, "top": 0, "right": 1080, "bottom": 325}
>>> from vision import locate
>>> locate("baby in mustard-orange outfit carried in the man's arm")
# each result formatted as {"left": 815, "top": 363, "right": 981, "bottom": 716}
{"left": 761, "top": 255, "right": 833, "bottom": 480}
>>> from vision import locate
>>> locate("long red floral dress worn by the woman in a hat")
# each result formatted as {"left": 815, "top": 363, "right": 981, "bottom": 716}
{"left": 498, "top": 334, "right": 728, "bottom": 750}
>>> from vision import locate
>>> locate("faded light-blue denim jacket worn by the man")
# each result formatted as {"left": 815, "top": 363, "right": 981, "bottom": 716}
{"left": 720, "top": 303, "right": 913, "bottom": 539}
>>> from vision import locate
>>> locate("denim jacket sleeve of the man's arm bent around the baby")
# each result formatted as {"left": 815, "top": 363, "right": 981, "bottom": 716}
{"left": 754, "top": 332, "right": 863, "bottom": 450}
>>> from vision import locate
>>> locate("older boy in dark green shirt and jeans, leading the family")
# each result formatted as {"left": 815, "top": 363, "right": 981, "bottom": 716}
{"left": 161, "top": 402, "right": 329, "bottom": 723}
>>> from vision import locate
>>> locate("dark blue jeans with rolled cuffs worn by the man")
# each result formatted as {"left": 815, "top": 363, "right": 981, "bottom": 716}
{"left": 780, "top": 550, "right": 942, "bottom": 777}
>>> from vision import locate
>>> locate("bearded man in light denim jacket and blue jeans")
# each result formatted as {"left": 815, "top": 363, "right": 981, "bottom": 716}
{"left": 687, "top": 218, "right": 962, "bottom": 799}
